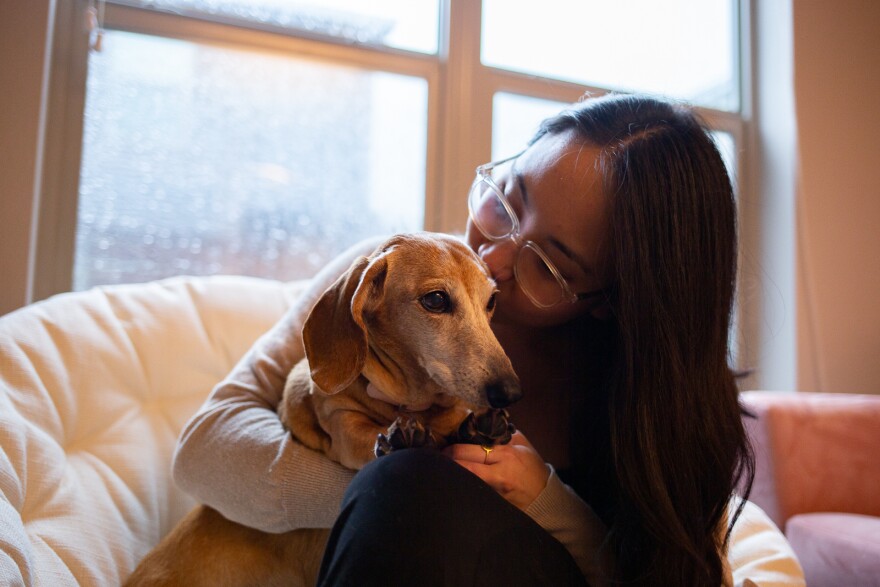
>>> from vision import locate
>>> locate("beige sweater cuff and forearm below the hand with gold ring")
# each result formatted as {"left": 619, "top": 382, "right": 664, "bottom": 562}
{"left": 526, "top": 465, "right": 611, "bottom": 585}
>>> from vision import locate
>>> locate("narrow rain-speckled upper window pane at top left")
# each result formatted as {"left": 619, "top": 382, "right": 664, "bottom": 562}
{"left": 140, "top": 0, "right": 440, "bottom": 54}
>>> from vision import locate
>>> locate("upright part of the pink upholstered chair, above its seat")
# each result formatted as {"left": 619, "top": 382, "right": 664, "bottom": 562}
{"left": 741, "top": 391, "right": 880, "bottom": 528}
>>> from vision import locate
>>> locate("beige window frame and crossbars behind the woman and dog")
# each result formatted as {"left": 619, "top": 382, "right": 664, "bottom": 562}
{"left": 32, "top": 0, "right": 758, "bottom": 338}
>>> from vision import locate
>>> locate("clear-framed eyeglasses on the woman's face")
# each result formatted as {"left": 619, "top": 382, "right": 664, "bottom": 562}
{"left": 468, "top": 153, "right": 605, "bottom": 308}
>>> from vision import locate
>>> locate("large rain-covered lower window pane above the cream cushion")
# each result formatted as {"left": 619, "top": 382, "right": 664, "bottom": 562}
{"left": 74, "top": 31, "right": 427, "bottom": 289}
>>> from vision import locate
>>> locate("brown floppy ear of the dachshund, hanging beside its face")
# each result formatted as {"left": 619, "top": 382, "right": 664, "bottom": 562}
{"left": 303, "top": 254, "right": 388, "bottom": 394}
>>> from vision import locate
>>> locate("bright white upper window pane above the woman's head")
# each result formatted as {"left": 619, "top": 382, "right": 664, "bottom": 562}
{"left": 482, "top": 0, "right": 739, "bottom": 111}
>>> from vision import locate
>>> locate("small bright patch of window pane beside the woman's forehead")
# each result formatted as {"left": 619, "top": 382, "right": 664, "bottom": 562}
{"left": 492, "top": 92, "right": 568, "bottom": 161}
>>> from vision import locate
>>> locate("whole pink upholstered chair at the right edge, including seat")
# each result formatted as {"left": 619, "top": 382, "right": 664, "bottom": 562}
{"left": 743, "top": 391, "right": 880, "bottom": 587}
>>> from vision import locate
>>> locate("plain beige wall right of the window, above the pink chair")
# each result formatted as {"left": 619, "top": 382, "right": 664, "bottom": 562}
{"left": 794, "top": 0, "right": 880, "bottom": 394}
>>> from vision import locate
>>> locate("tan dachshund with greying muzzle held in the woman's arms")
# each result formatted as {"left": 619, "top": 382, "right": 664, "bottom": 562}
{"left": 126, "top": 233, "right": 522, "bottom": 587}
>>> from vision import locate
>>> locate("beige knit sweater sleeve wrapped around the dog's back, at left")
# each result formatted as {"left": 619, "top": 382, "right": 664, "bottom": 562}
{"left": 173, "top": 240, "right": 380, "bottom": 532}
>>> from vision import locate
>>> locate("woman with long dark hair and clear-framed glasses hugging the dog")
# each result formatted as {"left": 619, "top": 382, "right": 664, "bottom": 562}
{"left": 174, "top": 96, "right": 797, "bottom": 585}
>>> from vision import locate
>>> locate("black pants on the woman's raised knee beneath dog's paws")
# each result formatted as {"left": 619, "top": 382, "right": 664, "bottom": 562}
{"left": 318, "top": 449, "right": 585, "bottom": 587}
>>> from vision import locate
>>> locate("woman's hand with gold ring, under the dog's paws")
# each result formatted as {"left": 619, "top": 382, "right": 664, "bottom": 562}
{"left": 443, "top": 432, "right": 550, "bottom": 510}
